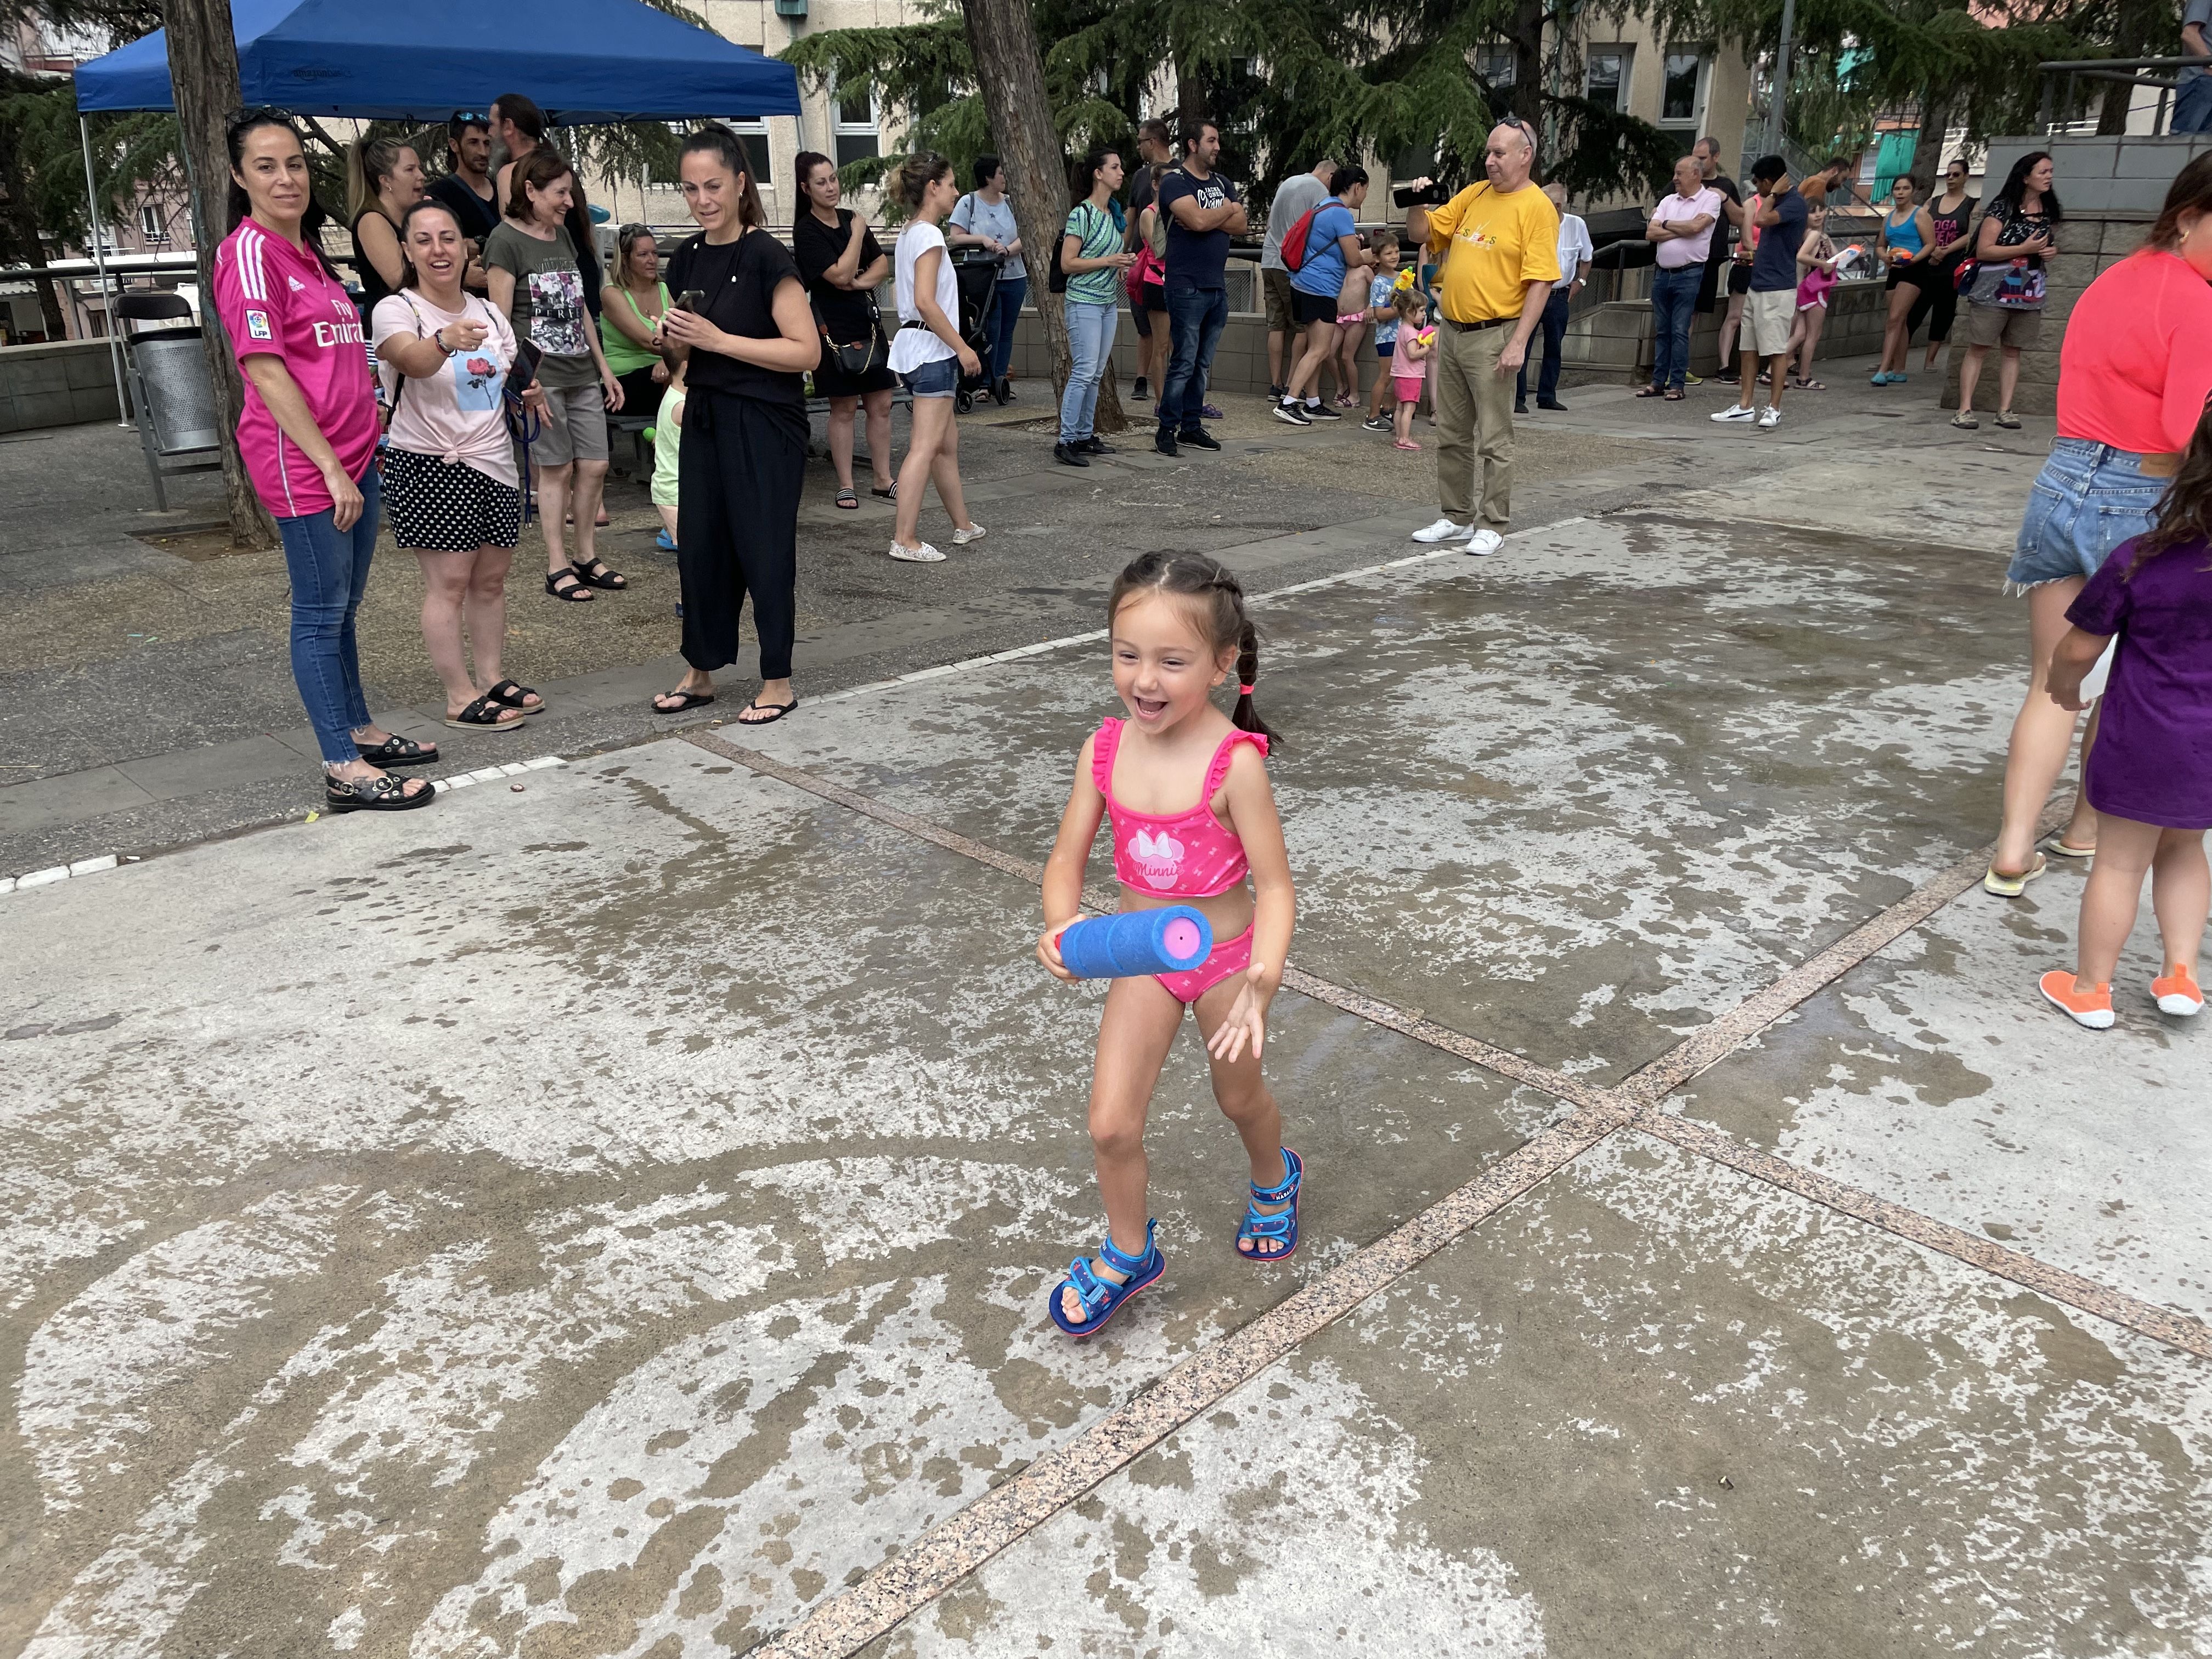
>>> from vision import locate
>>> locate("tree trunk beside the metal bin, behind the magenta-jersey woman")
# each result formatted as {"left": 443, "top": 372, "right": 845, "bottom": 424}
{"left": 161, "top": 0, "right": 276, "bottom": 546}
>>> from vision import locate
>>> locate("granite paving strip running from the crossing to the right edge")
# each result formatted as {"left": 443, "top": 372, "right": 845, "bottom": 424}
{"left": 1630, "top": 1106, "right": 2212, "bottom": 1361}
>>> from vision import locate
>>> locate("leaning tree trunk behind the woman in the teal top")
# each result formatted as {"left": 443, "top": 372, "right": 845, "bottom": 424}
{"left": 960, "top": 0, "right": 1079, "bottom": 409}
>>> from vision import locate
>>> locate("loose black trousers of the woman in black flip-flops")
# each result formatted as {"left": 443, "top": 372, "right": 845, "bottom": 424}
{"left": 677, "top": 387, "right": 808, "bottom": 679}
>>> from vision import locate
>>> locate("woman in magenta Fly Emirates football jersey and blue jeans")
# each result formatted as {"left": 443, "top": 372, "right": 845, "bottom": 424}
{"left": 215, "top": 113, "right": 438, "bottom": 812}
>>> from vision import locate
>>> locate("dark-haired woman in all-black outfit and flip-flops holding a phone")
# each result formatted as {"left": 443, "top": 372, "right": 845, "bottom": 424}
{"left": 652, "top": 122, "right": 823, "bottom": 725}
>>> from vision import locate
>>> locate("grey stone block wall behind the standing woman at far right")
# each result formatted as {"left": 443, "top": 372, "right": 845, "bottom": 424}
{"left": 1942, "top": 133, "right": 2212, "bottom": 414}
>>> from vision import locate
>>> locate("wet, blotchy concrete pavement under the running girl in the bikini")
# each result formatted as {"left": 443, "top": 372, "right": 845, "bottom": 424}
{"left": 0, "top": 369, "right": 2212, "bottom": 1659}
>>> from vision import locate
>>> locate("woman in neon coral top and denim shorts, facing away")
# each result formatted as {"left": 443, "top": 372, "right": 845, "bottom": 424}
{"left": 1982, "top": 155, "right": 2212, "bottom": 898}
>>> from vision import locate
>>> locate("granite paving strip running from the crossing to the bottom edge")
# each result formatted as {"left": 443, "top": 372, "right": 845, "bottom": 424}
{"left": 752, "top": 1104, "right": 1626, "bottom": 1659}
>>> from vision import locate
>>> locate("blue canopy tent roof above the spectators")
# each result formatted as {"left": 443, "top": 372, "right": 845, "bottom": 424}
{"left": 77, "top": 0, "right": 799, "bottom": 124}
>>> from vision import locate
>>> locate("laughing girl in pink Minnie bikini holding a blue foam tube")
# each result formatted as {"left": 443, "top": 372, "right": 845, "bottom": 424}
{"left": 1037, "top": 553, "right": 1303, "bottom": 1336}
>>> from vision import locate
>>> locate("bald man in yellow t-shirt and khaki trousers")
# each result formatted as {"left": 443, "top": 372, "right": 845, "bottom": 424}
{"left": 1413, "top": 117, "right": 1560, "bottom": 553}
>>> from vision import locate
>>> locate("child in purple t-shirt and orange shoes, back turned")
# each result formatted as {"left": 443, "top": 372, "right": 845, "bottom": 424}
{"left": 2042, "top": 436, "right": 2212, "bottom": 1031}
